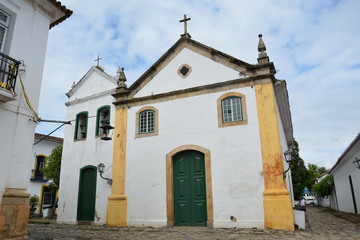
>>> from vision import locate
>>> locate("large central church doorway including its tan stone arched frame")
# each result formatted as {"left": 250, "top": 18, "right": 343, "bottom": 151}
{"left": 166, "top": 145, "right": 214, "bottom": 227}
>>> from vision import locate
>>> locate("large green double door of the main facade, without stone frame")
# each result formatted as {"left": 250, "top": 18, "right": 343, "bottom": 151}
{"left": 173, "top": 151, "right": 207, "bottom": 226}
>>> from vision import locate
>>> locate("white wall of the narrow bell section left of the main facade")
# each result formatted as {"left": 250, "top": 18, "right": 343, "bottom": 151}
{"left": 57, "top": 71, "right": 116, "bottom": 224}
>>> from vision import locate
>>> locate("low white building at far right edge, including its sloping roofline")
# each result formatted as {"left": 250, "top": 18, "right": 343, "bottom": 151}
{"left": 329, "top": 133, "right": 360, "bottom": 213}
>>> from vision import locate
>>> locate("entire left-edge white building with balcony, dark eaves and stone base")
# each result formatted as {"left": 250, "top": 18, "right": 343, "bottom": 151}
{"left": 0, "top": 0, "right": 72, "bottom": 239}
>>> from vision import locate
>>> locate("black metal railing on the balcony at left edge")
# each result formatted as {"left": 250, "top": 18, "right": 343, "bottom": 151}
{"left": 0, "top": 52, "right": 20, "bottom": 92}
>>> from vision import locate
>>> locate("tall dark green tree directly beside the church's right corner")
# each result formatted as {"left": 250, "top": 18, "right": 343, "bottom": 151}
{"left": 290, "top": 141, "right": 309, "bottom": 200}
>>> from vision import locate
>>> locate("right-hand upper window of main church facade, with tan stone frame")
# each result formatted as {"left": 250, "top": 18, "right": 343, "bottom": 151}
{"left": 217, "top": 92, "right": 247, "bottom": 127}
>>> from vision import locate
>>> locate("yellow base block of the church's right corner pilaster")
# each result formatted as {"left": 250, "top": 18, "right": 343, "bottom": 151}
{"left": 264, "top": 189, "right": 295, "bottom": 231}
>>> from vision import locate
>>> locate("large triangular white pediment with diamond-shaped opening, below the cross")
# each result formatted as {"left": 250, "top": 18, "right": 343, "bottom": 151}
{"left": 129, "top": 37, "right": 254, "bottom": 98}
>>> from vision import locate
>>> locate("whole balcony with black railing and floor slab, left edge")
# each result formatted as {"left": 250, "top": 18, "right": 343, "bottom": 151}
{"left": 0, "top": 52, "right": 20, "bottom": 102}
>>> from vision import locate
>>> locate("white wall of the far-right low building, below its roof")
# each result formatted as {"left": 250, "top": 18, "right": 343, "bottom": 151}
{"left": 331, "top": 148, "right": 360, "bottom": 213}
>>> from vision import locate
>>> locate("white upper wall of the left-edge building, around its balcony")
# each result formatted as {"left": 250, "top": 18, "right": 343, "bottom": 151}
{"left": 0, "top": 0, "right": 55, "bottom": 202}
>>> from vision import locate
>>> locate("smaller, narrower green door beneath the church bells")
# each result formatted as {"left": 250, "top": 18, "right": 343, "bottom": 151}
{"left": 77, "top": 166, "right": 96, "bottom": 221}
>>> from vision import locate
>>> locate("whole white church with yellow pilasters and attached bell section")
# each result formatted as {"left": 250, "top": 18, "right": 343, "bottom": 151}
{"left": 57, "top": 26, "right": 294, "bottom": 231}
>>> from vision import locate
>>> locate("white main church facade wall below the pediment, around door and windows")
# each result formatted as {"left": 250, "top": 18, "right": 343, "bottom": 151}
{"left": 126, "top": 86, "right": 264, "bottom": 228}
